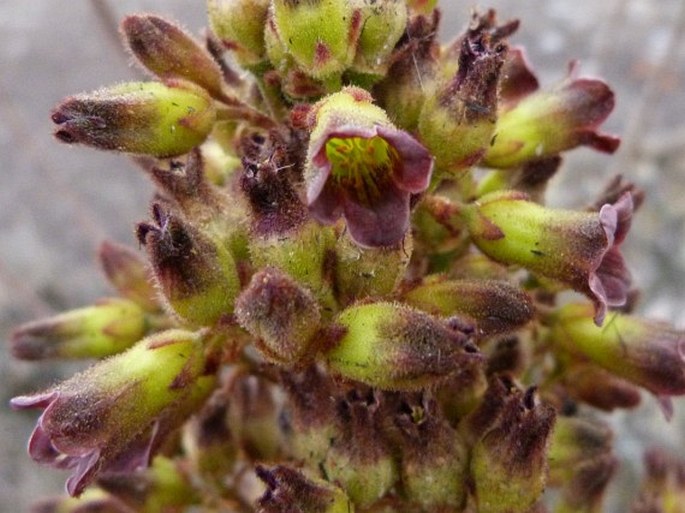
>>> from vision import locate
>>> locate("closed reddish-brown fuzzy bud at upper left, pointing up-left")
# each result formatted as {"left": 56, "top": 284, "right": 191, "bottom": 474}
{"left": 121, "top": 14, "right": 223, "bottom": 98}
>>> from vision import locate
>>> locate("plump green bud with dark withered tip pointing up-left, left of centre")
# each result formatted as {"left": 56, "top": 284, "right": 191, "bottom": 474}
{"left": 138, "top": 205, "right": 240, "bottom": 326}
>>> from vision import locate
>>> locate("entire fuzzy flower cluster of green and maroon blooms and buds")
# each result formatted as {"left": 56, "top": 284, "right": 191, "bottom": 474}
{"left": 11, "top": 0, "right": 685, "bottom": 513}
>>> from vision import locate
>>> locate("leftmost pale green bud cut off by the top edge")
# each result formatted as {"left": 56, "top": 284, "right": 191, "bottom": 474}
{"left": 207, "top": 0, "right": 270, "bottom": 69}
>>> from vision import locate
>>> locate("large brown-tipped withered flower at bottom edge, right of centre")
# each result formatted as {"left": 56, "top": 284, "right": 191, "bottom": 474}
{"left": 471, "top": 382, "right": 555, "bottom": 513}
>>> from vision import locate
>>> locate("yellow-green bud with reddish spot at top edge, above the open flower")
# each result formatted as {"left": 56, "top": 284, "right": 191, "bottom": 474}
{"left": 271, "top": 0, "right": 363, "bottom": 79}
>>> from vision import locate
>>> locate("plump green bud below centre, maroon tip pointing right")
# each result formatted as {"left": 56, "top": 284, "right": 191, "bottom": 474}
{"left": 325, "top": 302, "right": 482, "bottom": 390}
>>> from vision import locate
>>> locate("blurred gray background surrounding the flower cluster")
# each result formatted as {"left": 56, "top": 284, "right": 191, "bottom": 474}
{"left": 0, "top": 0, "right": 685, "bottom": 513}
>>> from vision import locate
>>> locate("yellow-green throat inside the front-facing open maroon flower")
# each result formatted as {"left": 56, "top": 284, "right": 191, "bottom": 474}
{"left": 326, "top": 136, "right": 399, "bottom": 206}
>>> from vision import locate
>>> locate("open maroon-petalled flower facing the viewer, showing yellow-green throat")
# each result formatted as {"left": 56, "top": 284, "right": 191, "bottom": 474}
{"left": 305, "top": 87, "right": 433, "bottom": 247}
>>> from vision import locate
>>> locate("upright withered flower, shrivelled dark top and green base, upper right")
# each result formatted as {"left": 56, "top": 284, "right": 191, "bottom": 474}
{"left": 418, "top": 11, "right": 507, "bottom": 176}
